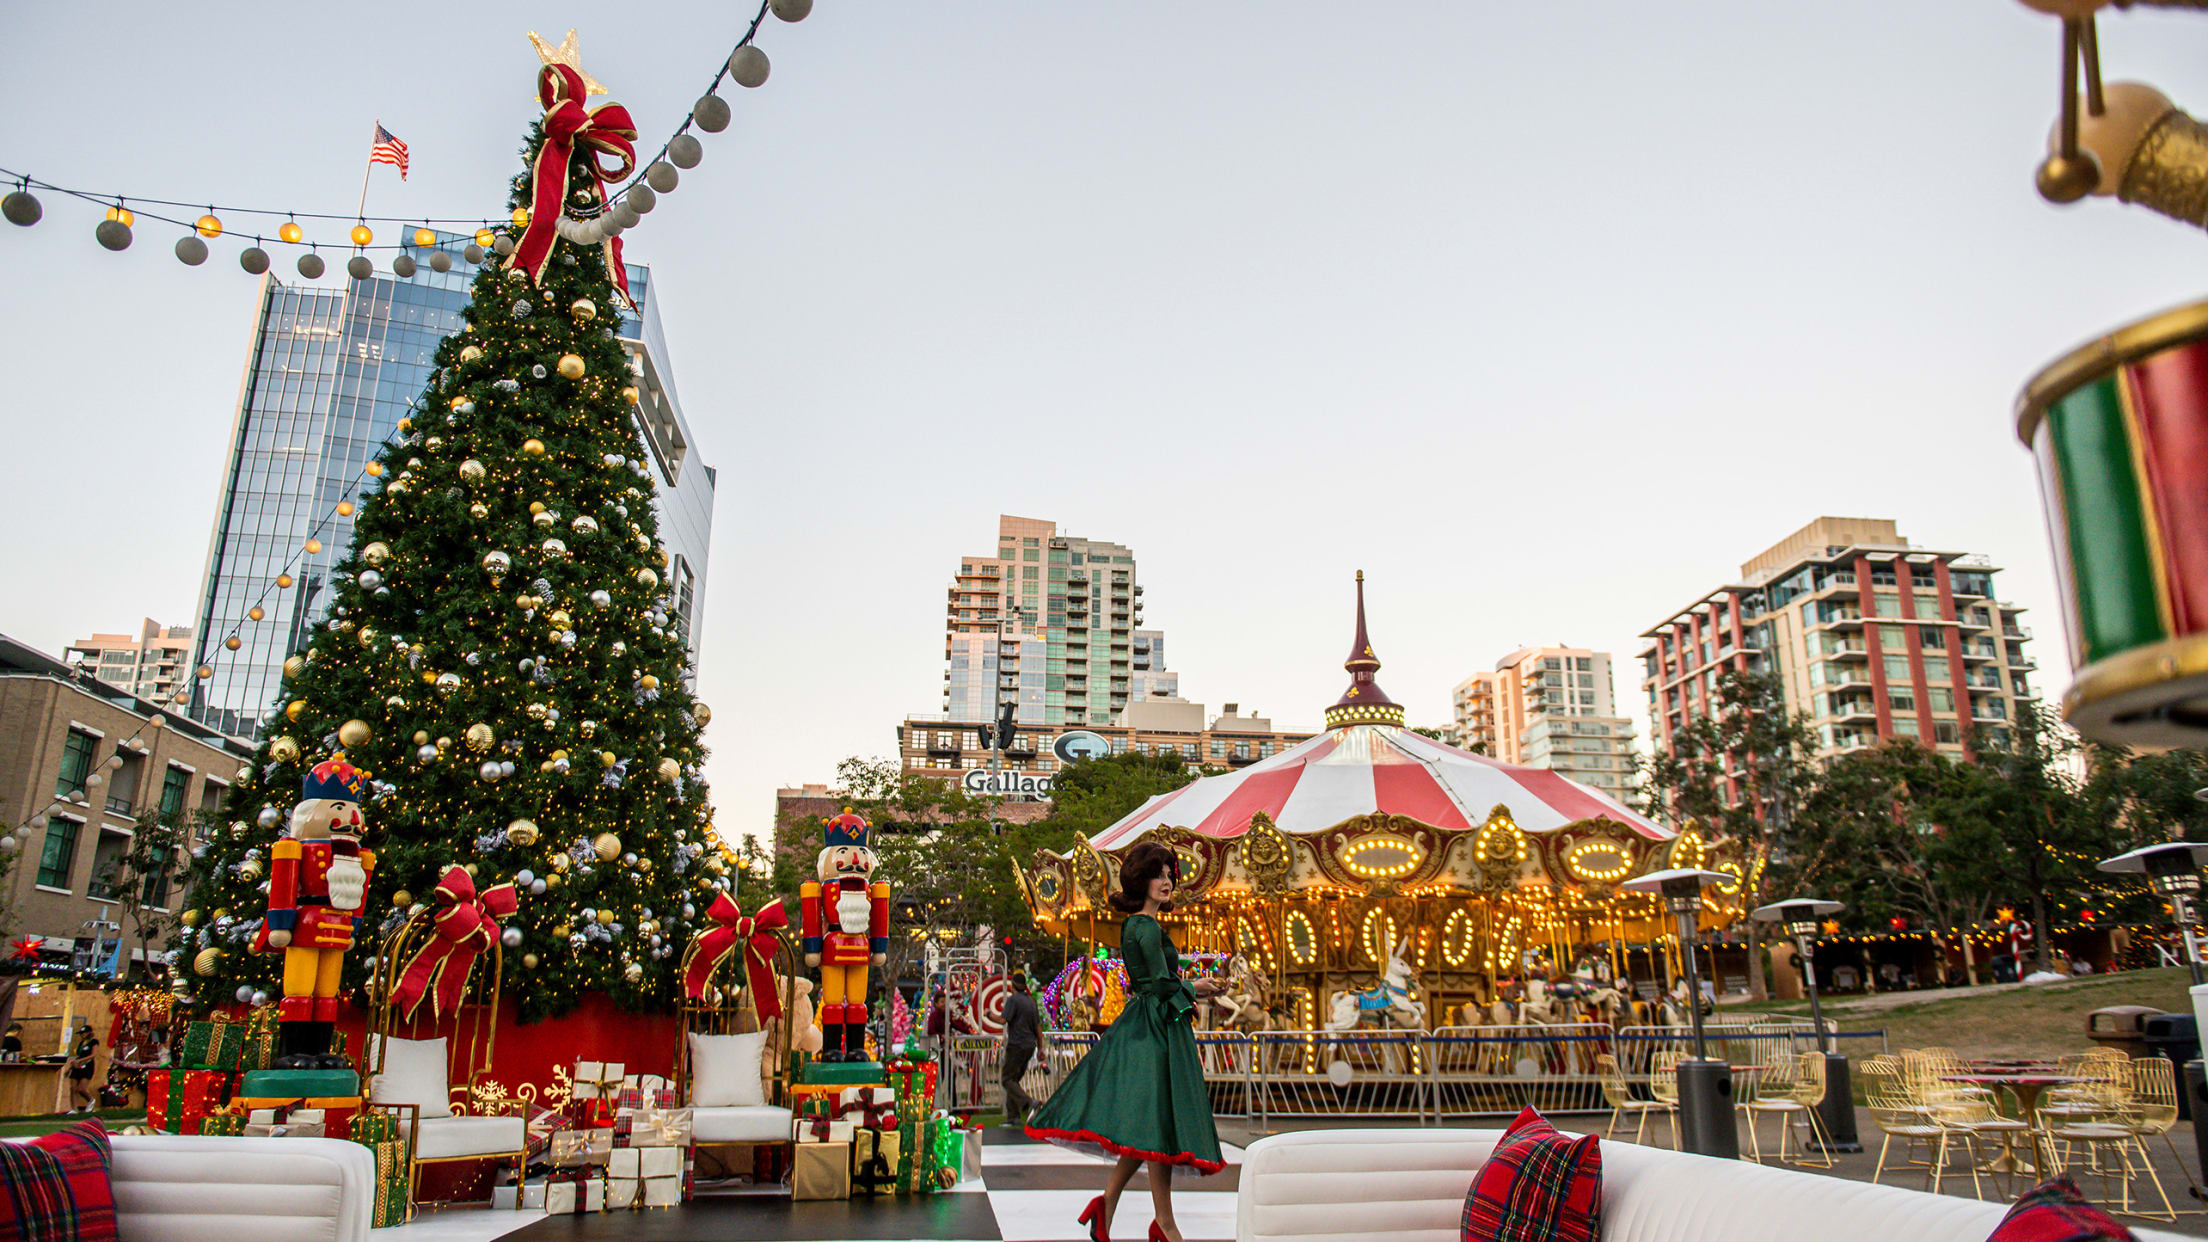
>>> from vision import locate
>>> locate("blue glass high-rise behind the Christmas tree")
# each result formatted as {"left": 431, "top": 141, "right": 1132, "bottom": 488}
{"left": 190, "top": 236, "right": 715, "bottom": 736}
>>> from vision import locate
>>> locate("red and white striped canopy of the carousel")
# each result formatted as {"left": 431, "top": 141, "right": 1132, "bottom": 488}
{"left": 1089, "top": 725, "right": 1678, "bottom": 849}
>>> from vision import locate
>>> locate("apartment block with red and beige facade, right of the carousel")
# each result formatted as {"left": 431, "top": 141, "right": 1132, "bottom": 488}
{"left": 1641, "top": 517, "right": 2038, "bottom": 791}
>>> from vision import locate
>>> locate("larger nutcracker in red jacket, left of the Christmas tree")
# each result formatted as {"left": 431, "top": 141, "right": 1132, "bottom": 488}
{"left": 254, "top": 754, "right": 375, "bottom": 1070}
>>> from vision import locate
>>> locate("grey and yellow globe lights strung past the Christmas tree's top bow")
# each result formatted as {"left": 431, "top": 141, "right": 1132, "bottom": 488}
{"left": 0, "top": 0, "right": 813, "bottom": 281}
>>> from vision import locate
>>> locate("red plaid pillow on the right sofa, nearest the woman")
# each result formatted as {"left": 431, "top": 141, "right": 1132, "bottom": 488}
{"left": 1459, "top": 1109, "right": 1603, "bottom": 1242}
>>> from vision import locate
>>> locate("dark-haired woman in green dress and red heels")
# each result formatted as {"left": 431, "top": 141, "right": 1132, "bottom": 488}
{"left": 1027, "top": 842, "right": 1225, "bottom": 1242}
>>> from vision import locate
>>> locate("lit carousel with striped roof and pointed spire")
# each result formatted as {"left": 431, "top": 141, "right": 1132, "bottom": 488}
{"left": 1020, "top": 572, "right": 1762, "bottom": 1030}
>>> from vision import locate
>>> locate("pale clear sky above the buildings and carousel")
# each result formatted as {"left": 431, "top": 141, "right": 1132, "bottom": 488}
{"left": 0, "top": 0, "right": 2208, "bottom": 835}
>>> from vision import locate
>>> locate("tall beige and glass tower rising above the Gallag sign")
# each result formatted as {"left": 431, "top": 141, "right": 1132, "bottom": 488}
{"left": 943, "top": 515, "right": 1181, "bottom": 725}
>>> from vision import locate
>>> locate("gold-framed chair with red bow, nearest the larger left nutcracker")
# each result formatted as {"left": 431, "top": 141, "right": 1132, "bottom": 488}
{"left": 362, "top": 906, "right": 537, "bottom": 1220}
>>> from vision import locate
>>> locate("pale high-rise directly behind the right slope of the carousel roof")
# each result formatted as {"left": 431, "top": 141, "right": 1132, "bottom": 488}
{"left": 1451, "top": 648, "right": 1634, "bottom": 798}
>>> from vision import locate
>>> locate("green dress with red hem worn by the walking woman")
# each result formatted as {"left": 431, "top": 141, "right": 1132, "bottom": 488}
{"left": 1027, "top": 915, "right": 1225, "bottom": 1176}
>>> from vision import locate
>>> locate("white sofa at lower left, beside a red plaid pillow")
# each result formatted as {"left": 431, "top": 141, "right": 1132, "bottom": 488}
{"left": 110, "top": 1134, "right": 375, "bottom": 1242}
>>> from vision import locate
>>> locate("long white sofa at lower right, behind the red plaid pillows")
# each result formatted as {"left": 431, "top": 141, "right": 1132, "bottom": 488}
{"left": 1234, "top": 1129, "right": 2179, "bottom": 1242}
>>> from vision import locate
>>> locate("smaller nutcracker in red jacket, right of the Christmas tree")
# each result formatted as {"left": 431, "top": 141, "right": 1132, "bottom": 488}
{"left": 797, "top": 807, "right": 890, "bottom": 1061}
